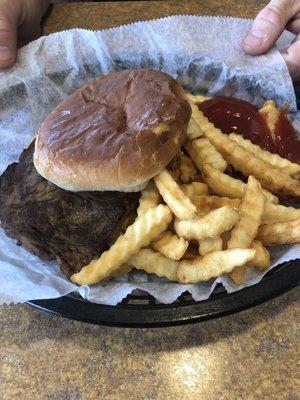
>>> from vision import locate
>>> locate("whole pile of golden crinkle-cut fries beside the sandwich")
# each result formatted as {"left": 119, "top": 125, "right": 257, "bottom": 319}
{"left": 71, "top": 94, "right": 300, "bottom": 284}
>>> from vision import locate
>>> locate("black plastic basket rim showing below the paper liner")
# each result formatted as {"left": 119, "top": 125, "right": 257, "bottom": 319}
{"left": 28, "top": 260, "right": 300, "bottom": 328}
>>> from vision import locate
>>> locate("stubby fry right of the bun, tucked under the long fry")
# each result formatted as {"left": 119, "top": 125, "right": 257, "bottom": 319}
{"left": 184, "top": 138, "right": 227, "bottom": 172}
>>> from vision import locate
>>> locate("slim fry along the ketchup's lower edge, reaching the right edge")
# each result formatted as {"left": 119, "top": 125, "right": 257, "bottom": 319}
{"left": 229, "top": 133, "right": 300, "bottom": 176}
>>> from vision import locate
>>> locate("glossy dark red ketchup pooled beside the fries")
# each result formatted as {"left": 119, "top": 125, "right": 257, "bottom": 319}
{"left": 198, "top": 97, "right": 300, "bottom": 163}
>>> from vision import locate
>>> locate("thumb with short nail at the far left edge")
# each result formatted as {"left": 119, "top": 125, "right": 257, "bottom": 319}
{"left": 0, "top": 8, "right": 17, "bottom": 68}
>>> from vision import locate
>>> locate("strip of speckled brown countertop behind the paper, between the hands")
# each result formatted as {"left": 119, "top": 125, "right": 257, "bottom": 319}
{"left": 44, "top": 0, "right": 267, "bottom": 34}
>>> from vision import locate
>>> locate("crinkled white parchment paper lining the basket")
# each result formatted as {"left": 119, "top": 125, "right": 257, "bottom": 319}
{"left": 0, "top": 16, "right": 300, "bottom": 305}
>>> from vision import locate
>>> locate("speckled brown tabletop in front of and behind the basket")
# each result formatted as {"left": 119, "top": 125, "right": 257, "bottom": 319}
{"left": 0, "top": 0, "right": 300, "bottom": 400}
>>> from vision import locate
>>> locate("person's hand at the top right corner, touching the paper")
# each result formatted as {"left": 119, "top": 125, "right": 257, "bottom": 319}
{"left": 243, "top": 0, "right": 300, "bottom": 80}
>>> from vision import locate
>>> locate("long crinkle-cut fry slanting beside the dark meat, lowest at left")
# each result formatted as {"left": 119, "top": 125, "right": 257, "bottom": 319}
{"left": 71, "top": 204, "right": 172, "bottom": 285}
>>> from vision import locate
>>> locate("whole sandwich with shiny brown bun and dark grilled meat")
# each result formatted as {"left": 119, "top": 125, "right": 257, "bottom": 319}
{"left": 0, "top": 70, "right": 191, "bottom": 276}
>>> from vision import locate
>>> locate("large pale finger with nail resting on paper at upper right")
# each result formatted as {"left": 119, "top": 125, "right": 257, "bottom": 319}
{"left": 243, "top": 0, "right": 300, "bottom": 54}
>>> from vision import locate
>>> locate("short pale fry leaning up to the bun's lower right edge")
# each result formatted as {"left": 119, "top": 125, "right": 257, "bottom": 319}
{"left": 154, "top": 169, "right": 197, "bottom": 219}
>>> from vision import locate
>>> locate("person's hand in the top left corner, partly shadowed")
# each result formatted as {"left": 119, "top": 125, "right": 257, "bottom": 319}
{"left": 0, "top": 0, "right": 50, "bottom": 68}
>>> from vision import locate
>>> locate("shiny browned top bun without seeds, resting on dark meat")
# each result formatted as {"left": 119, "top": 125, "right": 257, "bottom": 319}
{"left": 34, "top": 69, "right": 191, "bottom": 192}
